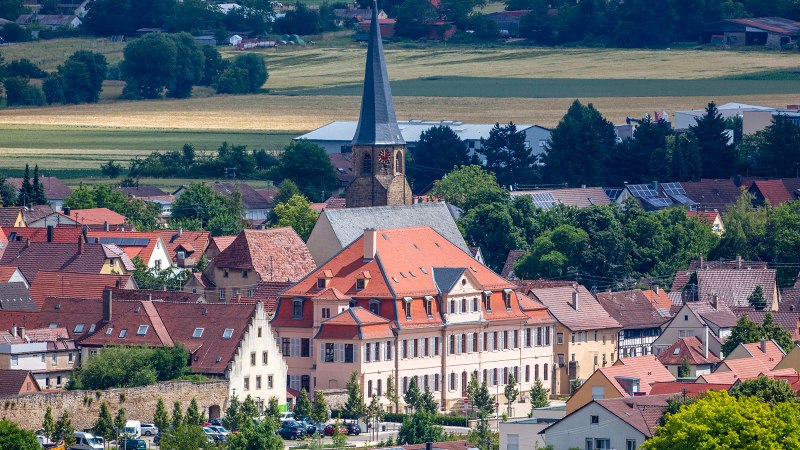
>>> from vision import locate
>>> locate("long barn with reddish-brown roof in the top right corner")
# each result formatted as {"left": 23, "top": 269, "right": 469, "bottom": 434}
{"left": 702, "top": 17, "right": 800, "bottom": 47}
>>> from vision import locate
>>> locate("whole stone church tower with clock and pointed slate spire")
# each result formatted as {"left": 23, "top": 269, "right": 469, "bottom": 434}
{"left": 346, "top": 0, "right": 412, "bottom": 208}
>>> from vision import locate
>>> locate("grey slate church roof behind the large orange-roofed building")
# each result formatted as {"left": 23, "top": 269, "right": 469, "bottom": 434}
{"left": 322, "top": 202, "right": 469, "bottom": 253}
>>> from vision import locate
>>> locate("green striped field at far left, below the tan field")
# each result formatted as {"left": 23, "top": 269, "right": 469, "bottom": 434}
{"left": 0, "top": 125, "right": 301, "bottom": 178}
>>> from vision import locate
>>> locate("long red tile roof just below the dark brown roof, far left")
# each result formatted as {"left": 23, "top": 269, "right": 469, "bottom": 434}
{"left": 30, "top": 270, "right": 136, "bottom": 307}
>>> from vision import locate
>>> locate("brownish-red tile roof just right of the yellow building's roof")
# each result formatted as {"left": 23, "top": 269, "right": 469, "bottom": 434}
{"left": 595, "top": 289, "right": 669, "bottom": 329}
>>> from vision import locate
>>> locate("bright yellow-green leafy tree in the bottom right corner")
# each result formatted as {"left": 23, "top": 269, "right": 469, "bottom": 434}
{"left": 642, "top": 391, "right": 800, "bottom": 450}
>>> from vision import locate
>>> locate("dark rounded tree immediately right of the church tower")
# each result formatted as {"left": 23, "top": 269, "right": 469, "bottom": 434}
{"left": 406, "top": 126, "right": 480, "bottom": 192}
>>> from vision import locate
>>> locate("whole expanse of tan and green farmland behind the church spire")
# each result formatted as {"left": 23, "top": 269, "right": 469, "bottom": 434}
{"left": 0, "top": 38, "right": 800, "bottom": 176}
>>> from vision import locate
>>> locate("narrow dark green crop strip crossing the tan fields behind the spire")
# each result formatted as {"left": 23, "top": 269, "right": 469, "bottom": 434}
{"left": 282, "top": 77, "right": 800, "bottom": 98}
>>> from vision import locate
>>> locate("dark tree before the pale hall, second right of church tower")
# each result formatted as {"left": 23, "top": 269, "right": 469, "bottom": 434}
{"left": 478, "top": 122, "right": 537, "bottom": 188}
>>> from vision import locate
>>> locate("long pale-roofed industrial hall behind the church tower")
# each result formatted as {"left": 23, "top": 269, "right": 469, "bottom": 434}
{"left": 294, "top": 119, "right": 550, "bottom": 162}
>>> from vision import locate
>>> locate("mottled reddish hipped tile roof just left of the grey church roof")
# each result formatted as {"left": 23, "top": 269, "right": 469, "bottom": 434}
{"left": 212, "top": 227, "right": 316, "bottom": 281}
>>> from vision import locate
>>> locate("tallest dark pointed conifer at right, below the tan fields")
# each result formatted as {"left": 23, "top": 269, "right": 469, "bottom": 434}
{"left": 688, "top": 102, "right": 738, "bottom": 178}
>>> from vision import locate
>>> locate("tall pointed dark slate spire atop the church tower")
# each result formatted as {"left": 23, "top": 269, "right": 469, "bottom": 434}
{"left": 353, "top": 0, "right": 405, "bottom": 145}
